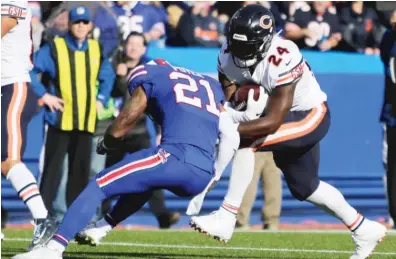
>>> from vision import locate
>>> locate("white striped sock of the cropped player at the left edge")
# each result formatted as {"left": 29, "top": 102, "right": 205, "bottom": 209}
{"left": 7, "top": 163, "right": 48, "bottom": 219}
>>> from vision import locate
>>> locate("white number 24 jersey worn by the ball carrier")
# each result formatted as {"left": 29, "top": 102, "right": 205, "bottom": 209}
{"left": 217, "top": 36, "right": 327, "bottom": 111}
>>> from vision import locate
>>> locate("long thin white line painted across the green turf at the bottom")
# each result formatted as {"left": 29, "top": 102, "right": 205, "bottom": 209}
{"left": 4, "top": 238, "right": 396, "bottom": 255}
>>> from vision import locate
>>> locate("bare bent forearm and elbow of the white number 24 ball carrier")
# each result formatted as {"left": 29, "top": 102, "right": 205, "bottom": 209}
{"left": 238, "top": 83, "right": 297, "bottom": 138}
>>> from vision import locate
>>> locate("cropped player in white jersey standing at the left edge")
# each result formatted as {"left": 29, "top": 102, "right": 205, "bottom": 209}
{"left": 1, "top": 1, "right": 54, "bottom": 252}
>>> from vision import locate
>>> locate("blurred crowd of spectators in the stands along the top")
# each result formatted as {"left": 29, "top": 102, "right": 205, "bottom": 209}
{"left": 32, "top": 1, "right": 391, "bottom": 55}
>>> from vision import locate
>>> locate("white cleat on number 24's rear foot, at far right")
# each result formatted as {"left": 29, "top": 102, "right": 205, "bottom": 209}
{"left": 350, "top": 219, "right": 387, "bottom": 259}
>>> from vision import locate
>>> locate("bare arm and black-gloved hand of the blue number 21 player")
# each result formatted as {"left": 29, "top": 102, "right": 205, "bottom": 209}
{"left": 97, "top": 86, "right": 147, "bottom": 154}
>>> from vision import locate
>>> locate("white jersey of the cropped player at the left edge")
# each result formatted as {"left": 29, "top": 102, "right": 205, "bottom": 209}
{"left": 1, "top": 1, "right": 33, "bottom": 86}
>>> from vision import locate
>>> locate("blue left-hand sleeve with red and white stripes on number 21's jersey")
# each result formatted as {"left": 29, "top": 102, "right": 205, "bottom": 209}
{"left": 128, "top": 65, "right": 154, "bottom": 99}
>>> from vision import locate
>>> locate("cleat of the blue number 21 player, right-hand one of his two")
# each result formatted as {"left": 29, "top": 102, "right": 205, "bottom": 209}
{"left": 75, "top": 219, "right": 112, "bottom": 246}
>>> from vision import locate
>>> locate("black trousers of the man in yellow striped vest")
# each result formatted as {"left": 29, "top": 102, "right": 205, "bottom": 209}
{"left": 40, "top": 126, "right": 93, "bottom": 212}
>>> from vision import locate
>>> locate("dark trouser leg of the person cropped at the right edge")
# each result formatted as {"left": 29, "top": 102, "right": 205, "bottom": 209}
{"left": 386, "top": 127, "right": 396, "bottom": 223}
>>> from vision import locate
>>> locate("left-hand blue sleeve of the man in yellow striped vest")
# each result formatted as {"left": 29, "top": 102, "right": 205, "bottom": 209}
{"left": 30, "top": 44, "right": 56, "bottom": 98}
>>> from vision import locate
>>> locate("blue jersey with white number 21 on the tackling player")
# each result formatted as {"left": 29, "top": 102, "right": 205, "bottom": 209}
{"left": 128, "top": 59, "right": 224, "bottom": 171}
